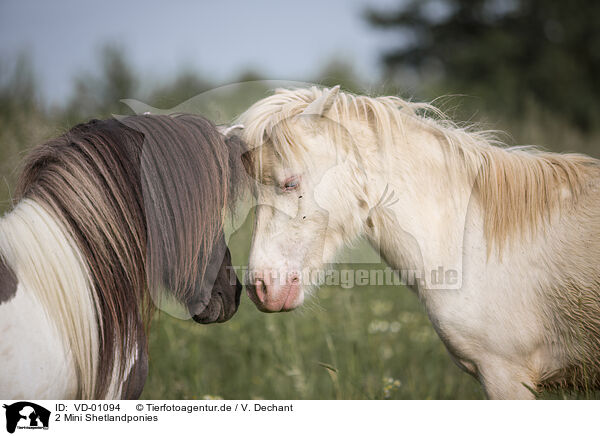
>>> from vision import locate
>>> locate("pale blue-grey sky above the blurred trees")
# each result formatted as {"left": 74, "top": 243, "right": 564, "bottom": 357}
{"left": 0, "top": 0, "right": 398, "bottom": 103}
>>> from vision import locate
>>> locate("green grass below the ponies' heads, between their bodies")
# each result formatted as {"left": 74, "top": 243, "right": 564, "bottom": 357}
{"left": 143, "top": 278, "right": 483, "bottom": 399}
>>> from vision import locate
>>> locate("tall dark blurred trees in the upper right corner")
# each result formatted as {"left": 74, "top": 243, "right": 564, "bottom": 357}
{"left": 367, "top": 0, "right": 600, "bottom": 131}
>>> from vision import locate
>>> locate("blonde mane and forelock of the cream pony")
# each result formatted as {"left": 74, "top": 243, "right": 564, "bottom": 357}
{"left": 237, "top": 87, "right": 600, "bottom": 250}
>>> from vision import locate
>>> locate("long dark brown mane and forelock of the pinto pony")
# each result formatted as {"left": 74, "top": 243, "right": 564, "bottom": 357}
{"left": 17, "top": 115, "right": 244, "bottom": 398}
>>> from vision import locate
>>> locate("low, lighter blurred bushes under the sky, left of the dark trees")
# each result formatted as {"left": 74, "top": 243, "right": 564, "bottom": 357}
{"left": 0, "top": 44, "right": 361, "bottom": 208}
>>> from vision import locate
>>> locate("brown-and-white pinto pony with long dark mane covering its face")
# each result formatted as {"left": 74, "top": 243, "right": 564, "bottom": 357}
{"left": 0, "top": 115, "right": 244, "bottom": 399}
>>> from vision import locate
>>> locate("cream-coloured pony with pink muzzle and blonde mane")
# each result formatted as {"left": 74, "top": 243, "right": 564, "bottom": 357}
{"left": 238, "top": 87, "right": 600, "bottom": 399}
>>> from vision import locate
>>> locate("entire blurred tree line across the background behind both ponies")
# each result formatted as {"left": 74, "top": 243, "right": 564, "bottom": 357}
{"left": 0, "top": 0, "right": 600, "bottom": 209}
